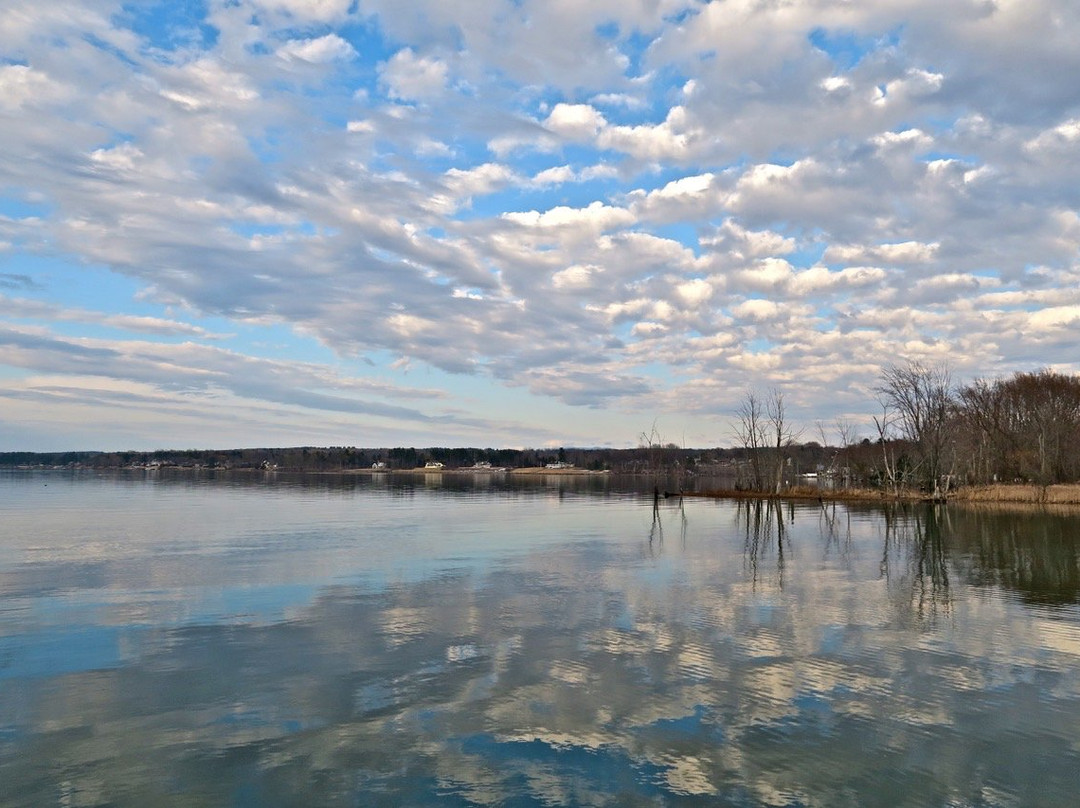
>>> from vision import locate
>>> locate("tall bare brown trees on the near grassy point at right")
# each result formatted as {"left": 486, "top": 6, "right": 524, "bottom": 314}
{"left": 735, "top": 361, "right": 1080, "bottom": 497}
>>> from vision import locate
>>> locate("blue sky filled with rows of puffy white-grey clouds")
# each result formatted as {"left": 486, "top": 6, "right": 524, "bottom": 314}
{"left": 0, "top": 0, "right": 1080, "bottom": 452}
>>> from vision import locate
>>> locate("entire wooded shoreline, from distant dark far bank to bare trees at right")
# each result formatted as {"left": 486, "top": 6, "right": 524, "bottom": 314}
{"left": 0, "top": 361, "right": 1080, "bottom": 488}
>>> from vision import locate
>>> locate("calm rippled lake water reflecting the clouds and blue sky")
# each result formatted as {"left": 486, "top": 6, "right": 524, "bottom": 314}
{"left": 0, "top": 473, "right": 1080, "bottom": 808}
